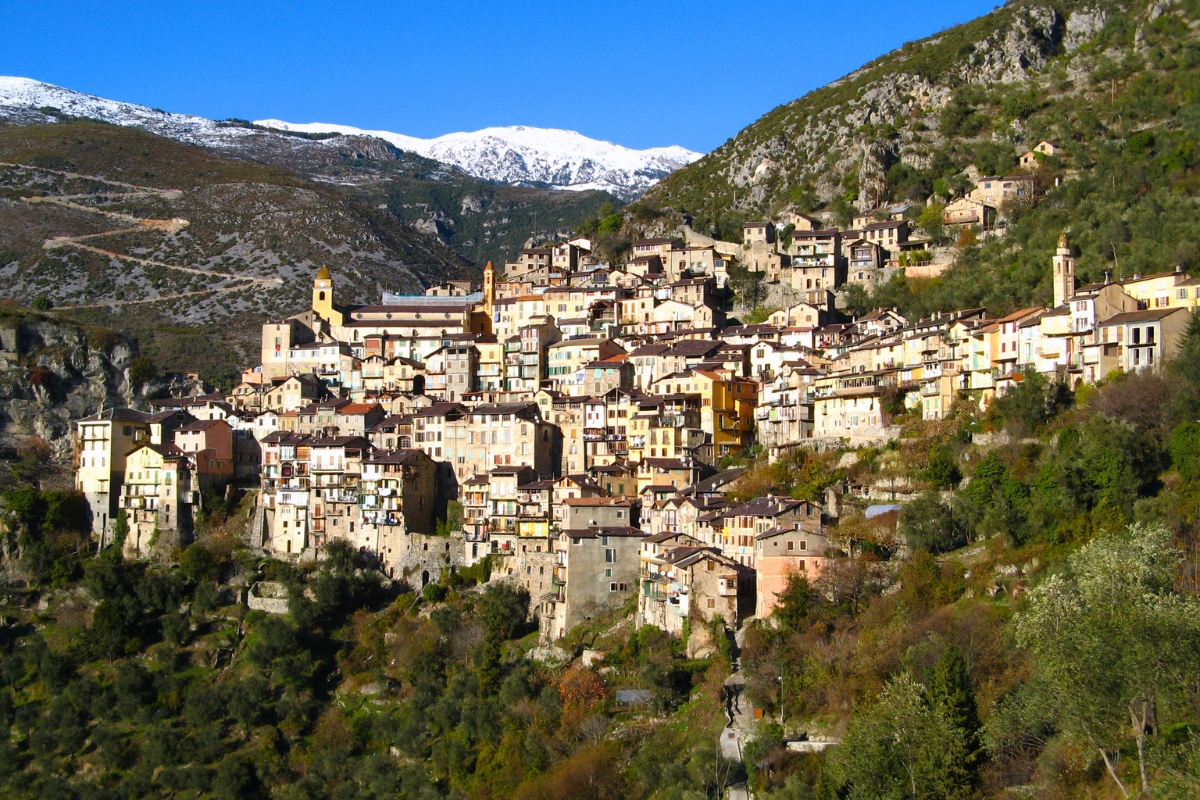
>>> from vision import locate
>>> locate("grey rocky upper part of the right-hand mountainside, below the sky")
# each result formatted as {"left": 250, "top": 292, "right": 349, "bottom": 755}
{"left": 647, "top": 0, "right": 1171, "bottom": 218}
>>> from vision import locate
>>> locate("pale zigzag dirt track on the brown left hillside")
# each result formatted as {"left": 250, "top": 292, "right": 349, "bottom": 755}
{"left": 0, "top": 162, "right": 283, "bottom": 308}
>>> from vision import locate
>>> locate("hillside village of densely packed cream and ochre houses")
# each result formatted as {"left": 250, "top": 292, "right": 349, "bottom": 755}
{"left": 74, "top": 130, "right": 1200, "bottom": 654}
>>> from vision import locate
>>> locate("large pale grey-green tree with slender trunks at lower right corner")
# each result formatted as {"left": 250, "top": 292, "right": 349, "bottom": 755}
{"left": 1016, "top": 524, "right": 1200, "bottom": 796}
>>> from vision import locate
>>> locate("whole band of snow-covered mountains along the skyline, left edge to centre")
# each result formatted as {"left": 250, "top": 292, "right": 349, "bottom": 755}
{"left": 0, "top": 77, "right": 702, "bottom": 199}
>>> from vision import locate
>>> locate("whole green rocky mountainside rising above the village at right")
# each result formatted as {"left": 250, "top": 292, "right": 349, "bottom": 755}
{"left": 647, "top": 0, "right": 1200, "bottom": 313}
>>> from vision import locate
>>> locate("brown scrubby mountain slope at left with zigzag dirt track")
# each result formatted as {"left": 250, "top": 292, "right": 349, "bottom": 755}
{"left": 0, "top": 122, "right": 474, "bottom": 375}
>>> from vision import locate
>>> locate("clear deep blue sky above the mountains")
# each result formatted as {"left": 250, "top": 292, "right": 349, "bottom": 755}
{"left": 0, "top": 0, "right": 996, "bottom": 151}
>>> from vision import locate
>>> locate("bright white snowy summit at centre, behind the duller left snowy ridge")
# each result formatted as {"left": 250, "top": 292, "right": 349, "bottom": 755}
{"left": 256, "top": 120, "right": 703, "bottom": 198}
